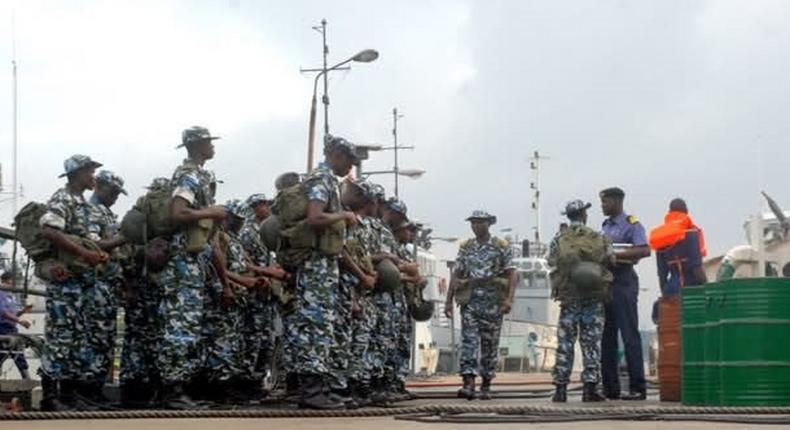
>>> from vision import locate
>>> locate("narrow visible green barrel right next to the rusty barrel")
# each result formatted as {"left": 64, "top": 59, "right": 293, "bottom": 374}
{"left": 680, "top": 287, "right": 706, "bottom": 405}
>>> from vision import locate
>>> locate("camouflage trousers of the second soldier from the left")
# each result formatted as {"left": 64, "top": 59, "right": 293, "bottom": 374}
{"left": 82, "top": 279, "right": 119, "bottom": 383}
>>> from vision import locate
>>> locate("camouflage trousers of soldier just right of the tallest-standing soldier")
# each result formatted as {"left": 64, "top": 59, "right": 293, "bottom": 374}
{"left": 203, "top": 281, "right": 248, "bottom": 381}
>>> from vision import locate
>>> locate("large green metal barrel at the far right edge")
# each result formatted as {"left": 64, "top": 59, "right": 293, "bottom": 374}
{"left": 719, "top": 278, "right": 790, "bottom": 406}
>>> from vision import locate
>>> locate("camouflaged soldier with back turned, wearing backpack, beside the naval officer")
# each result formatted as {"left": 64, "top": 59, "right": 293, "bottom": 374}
{"left": 548, "top": 200, "right": 614, "bottom": 402}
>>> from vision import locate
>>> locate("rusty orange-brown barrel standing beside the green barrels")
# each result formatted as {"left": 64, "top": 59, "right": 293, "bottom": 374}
{"left": 658, "top": 295, "right": 681, "bottom": 402}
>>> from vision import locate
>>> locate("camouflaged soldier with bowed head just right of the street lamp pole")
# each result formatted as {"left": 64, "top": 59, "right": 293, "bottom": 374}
{"left": 285, "top": 136, "right": 358, "bottom": 409}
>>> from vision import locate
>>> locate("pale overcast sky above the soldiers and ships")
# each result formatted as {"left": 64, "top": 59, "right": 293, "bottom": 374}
{"left": 0, "top": 0, "right": 790, "bottom": 326}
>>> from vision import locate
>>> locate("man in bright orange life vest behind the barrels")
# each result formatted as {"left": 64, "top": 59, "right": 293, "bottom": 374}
{"left": 650, "top": 198, "right": 707, "bottom": 297}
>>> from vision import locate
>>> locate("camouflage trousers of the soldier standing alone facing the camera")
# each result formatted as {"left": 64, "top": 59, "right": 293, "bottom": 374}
{"left": 460, "top": 286, "right": 502, "bottom": 378}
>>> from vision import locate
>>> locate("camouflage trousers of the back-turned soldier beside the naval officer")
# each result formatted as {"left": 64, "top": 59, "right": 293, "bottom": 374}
{"left": 553, "top": 300, "right": 604, "bottom": 384}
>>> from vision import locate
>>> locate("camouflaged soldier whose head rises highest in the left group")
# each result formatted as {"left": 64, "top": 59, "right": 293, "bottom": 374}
{"left": 159, "top": 126, "right": 226, "bottom": 409}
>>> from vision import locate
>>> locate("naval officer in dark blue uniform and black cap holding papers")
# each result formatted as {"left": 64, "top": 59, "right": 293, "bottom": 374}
{"left": 600, "top": 187, "right": 650, "bottom": 400}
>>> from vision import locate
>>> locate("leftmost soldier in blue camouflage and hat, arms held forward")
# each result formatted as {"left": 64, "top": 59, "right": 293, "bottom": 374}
{"left": 36, "top": 155, "right": 108, "bottom": 411}
